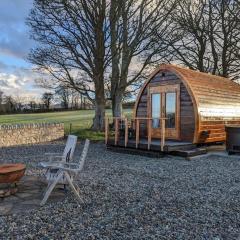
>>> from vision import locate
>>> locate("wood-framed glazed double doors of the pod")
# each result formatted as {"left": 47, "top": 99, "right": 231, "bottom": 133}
{"left": 148, "top": 84, "right": 180, "bottom": 139}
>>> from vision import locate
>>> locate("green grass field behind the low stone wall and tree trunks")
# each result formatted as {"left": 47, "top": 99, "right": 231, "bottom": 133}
{"left": 0, "top": 109, "right": 132, "bottom": 140}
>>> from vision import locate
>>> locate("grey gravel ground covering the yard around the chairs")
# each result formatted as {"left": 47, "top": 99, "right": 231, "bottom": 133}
{"left": 0, "top": 142, "right": 240, "bottom": 240}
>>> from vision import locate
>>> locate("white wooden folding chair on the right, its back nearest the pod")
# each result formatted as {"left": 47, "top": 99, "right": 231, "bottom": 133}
{"left": 40, "top": 139, "right": 90, "bottom": 206}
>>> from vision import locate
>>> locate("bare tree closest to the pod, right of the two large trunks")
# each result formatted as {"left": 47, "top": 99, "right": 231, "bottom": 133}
{"left": 109, "top": 0, "right": 175, "bottom": 117}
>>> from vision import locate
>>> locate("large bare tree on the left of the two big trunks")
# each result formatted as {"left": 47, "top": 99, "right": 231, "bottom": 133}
{"left": 27, "top": 0, "right": 108, "bottom": 129}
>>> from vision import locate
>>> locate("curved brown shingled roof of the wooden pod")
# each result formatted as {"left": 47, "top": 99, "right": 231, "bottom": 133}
{"left": 136, "top": 64, "right": 240, "bottom": 120}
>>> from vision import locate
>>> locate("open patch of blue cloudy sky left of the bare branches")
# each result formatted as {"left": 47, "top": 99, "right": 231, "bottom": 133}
{"left": 0, "top": 0, "right": 43, "bottom": 101}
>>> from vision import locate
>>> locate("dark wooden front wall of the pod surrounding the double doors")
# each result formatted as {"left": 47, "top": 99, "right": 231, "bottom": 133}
{"left": 134, "top": 68, "right": 195, "bottom": 142}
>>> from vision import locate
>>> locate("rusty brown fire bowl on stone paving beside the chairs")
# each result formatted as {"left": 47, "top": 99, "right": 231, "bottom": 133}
{"left": 0, "top": 163, "right": 26, "bottom": 197}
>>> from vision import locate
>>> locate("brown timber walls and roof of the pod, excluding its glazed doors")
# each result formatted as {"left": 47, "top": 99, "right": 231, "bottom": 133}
{"left": 134, "top": 64, "right": 240, "bottom": 143}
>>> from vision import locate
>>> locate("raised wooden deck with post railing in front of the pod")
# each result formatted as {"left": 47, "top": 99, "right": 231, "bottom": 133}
{"left": 105, "top": 118, "right": 206, "bottom": 157}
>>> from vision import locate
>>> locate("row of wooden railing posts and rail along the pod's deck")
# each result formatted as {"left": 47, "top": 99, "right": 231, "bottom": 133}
{"left": 105, "top": 117, "right": 167, "bottom": 151}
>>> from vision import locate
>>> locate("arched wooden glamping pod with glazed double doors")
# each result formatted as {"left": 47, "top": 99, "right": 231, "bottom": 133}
{"left": 133, "top": 64, "right": 240, "bottom": 144}
